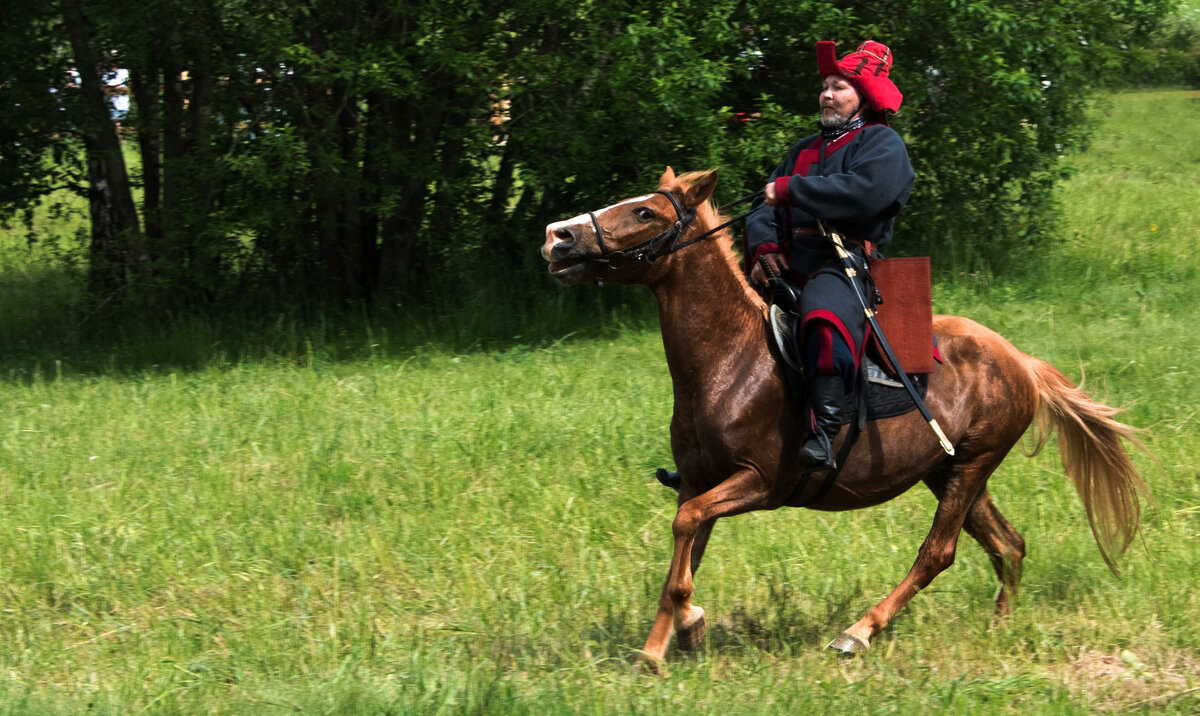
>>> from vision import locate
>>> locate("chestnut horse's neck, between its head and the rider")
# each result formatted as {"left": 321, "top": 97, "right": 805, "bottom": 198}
{"left": 650, "top": 243, "right": 766, "bottom": 385}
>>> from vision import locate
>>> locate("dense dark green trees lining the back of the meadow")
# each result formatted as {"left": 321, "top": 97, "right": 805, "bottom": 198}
{"left": 0, "top": 0, "right": 1200, "bottom": 308}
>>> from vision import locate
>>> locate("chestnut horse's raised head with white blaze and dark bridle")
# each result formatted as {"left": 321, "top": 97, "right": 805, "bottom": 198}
{"left": 541, "top": 167, "right": 716, "bottom": 285}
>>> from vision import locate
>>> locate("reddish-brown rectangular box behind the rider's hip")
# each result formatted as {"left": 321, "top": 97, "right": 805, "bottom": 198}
{"left": 871, "top": 257, "right": 934, "bottom": 374}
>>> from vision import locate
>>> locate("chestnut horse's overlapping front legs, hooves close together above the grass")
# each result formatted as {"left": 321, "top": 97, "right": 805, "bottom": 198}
{"left": 642, "top": 470, "right": 768, "bottom": 666}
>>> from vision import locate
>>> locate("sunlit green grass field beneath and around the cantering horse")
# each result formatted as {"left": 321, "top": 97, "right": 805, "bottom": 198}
{"left": 0, "top": 92, "right": 1200, "bottom": 715}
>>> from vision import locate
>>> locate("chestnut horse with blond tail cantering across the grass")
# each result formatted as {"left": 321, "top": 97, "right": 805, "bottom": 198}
{"left": 541, "top": 167, "right": 1145, "bottom": 664}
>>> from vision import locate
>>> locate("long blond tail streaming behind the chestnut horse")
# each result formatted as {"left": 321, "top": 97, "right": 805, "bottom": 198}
{"left": 1027, "top": 357, "right": 1146, "bottom": 573}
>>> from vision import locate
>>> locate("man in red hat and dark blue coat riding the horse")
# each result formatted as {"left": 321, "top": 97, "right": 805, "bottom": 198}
{"left": 746, "top": 41, "right": 913, "bottom": 469}
